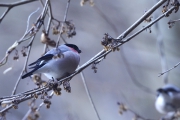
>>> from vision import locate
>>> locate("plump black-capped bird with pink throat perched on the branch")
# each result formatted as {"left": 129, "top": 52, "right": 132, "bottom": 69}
{"left": 21, "top": 44, "right": 81, "bottom": 80}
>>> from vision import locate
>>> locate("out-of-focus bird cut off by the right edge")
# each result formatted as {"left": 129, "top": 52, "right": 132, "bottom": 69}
{"left": 155, "top": 84, "right": 180, "bottom": 114}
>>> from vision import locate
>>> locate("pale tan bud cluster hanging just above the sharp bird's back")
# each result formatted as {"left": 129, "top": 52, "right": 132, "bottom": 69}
{"left": 40, "top": 30, "right": 56, "bottom": 47}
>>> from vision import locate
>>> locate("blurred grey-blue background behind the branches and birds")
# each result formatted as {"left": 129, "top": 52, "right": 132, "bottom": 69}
{"left": 0, "top": 0, "right": 180, "bottom": 120}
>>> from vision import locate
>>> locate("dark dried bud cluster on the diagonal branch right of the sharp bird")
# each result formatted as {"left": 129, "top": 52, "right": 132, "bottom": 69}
{"left": 101, "top": 33, "right": 122, "bottom": 51}
